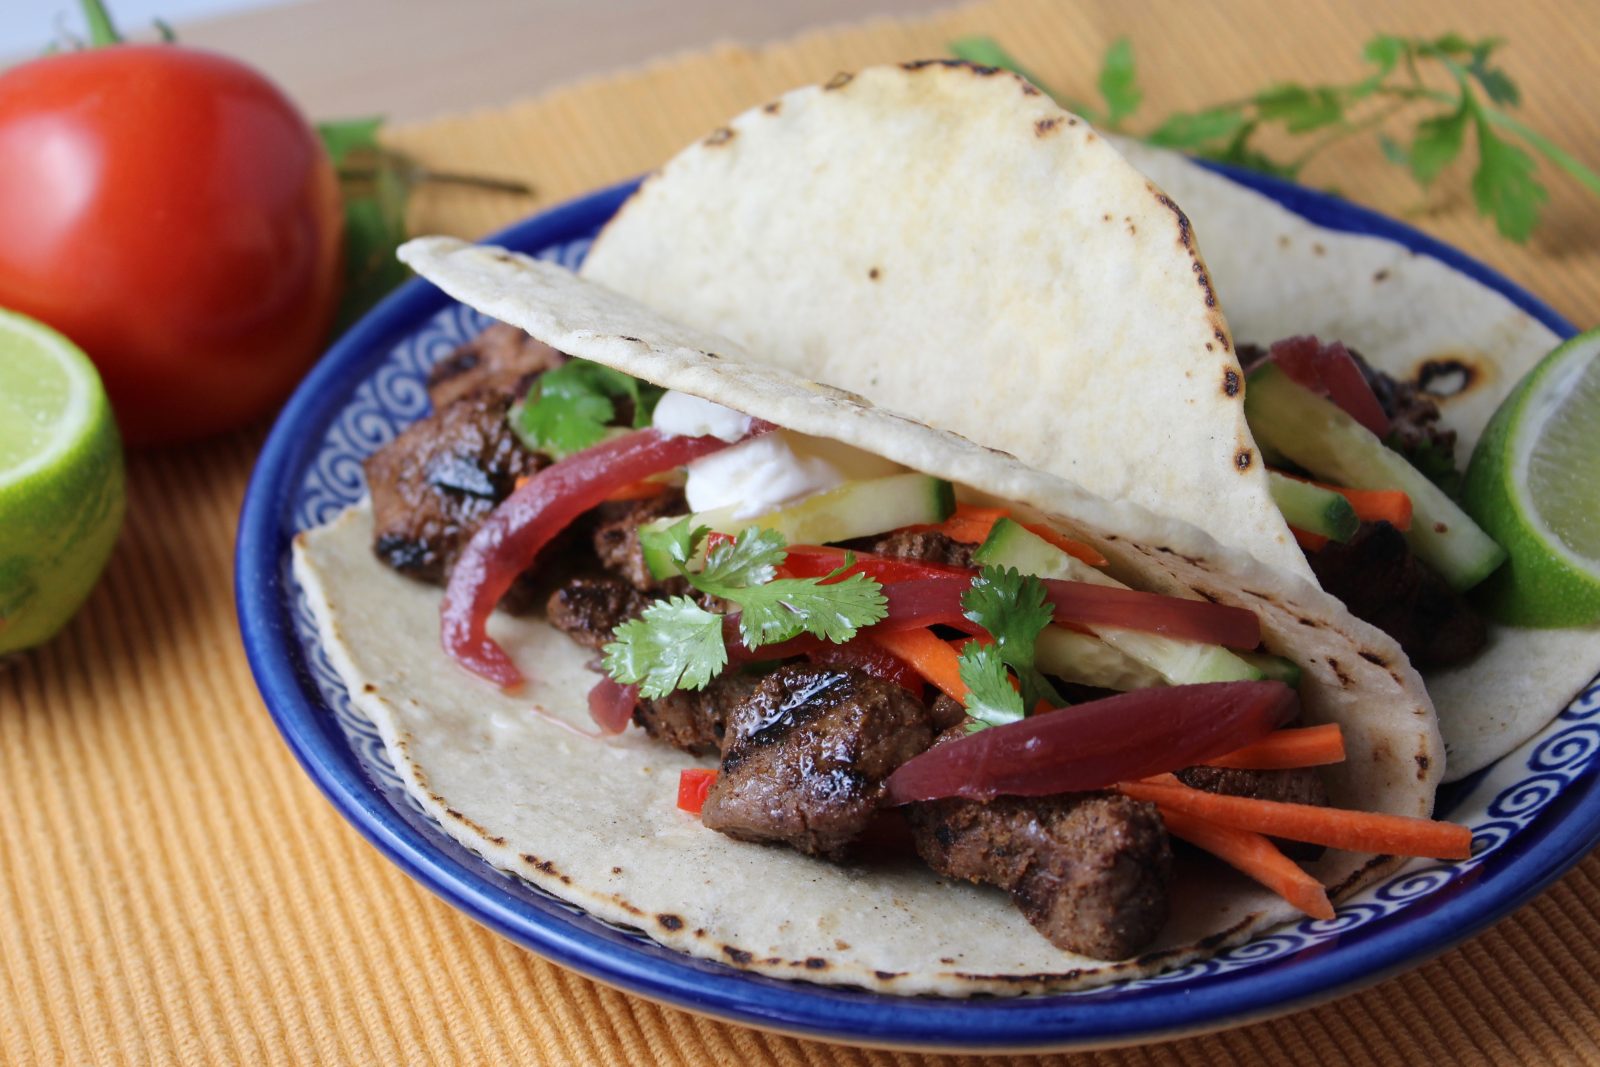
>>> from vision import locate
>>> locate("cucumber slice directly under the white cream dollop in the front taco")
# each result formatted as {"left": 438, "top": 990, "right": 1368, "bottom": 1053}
{"left": 645, "top": 472, "right": 955, "bottom": 579}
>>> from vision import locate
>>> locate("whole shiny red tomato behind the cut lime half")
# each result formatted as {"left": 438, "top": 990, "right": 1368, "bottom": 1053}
{"left": 0, "top": 45, "right": 342, "bottom": 442}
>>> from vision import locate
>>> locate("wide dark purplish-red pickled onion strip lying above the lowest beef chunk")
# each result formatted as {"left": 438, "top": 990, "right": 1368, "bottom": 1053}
{"left": 888, "top": 684, "right": 1298, "bottom": 805}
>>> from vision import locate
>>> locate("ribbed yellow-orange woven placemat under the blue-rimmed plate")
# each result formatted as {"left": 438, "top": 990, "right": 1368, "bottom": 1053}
{"left": 0, "top": 0, "right": 1600, "bottom": 1067}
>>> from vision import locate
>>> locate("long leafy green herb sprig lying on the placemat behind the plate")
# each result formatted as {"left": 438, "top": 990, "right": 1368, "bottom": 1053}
{"left": 950, "top": 34, "right": 1600, "bottom": 242}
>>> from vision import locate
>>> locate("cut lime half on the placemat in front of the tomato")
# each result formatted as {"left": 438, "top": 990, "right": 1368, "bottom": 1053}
{"left": 0, "top": 310, "right": 123, "bottom": 653}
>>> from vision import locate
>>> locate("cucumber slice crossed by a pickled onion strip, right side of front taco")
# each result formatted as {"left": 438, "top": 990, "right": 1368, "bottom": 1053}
{"left": 973, "top": 518, "right": 1261, "bottom": 688}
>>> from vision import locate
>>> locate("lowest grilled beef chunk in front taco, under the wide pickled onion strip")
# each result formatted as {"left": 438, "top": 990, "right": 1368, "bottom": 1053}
{"left": 906, "top": 793, "right": 1173, "bottom": 960}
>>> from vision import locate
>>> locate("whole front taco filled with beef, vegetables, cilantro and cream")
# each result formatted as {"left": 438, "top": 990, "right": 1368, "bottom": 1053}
{"left": 294, "top": 238, "right": 1469, "bottom": 995}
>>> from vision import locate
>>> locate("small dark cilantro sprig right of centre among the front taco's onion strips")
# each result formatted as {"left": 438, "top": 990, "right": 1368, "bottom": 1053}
{"left": 958, "top": 566, "right": 1066, "bottom": 729}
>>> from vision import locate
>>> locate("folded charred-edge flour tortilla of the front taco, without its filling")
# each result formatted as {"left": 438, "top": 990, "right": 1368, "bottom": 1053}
{"left": 294, "top": 238, "right": 1442, "bottom": 997}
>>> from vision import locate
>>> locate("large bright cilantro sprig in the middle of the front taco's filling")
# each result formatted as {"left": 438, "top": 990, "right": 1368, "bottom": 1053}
{"left": 603, "top": 518, "right": 888, "bottom": 699}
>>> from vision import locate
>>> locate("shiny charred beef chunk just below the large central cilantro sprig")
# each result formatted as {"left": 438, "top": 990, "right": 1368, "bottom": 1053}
{"left": 701, "top": 664, "right": 933, "bottom": 859}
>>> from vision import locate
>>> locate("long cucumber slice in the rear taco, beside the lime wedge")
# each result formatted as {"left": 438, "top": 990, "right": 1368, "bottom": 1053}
{"left": 1245, "top": 363, "right": 1506, "bottom": 592}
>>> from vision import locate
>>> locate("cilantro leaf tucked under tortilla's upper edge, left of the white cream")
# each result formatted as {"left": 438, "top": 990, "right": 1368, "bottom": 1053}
{"left": 510, "top": 360, "right": 662, "bottom": 459}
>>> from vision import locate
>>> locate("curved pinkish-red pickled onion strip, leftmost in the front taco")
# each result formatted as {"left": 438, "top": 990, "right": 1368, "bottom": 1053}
{"left": 440, "top": 422, "right": 771, "bottom": 689}
